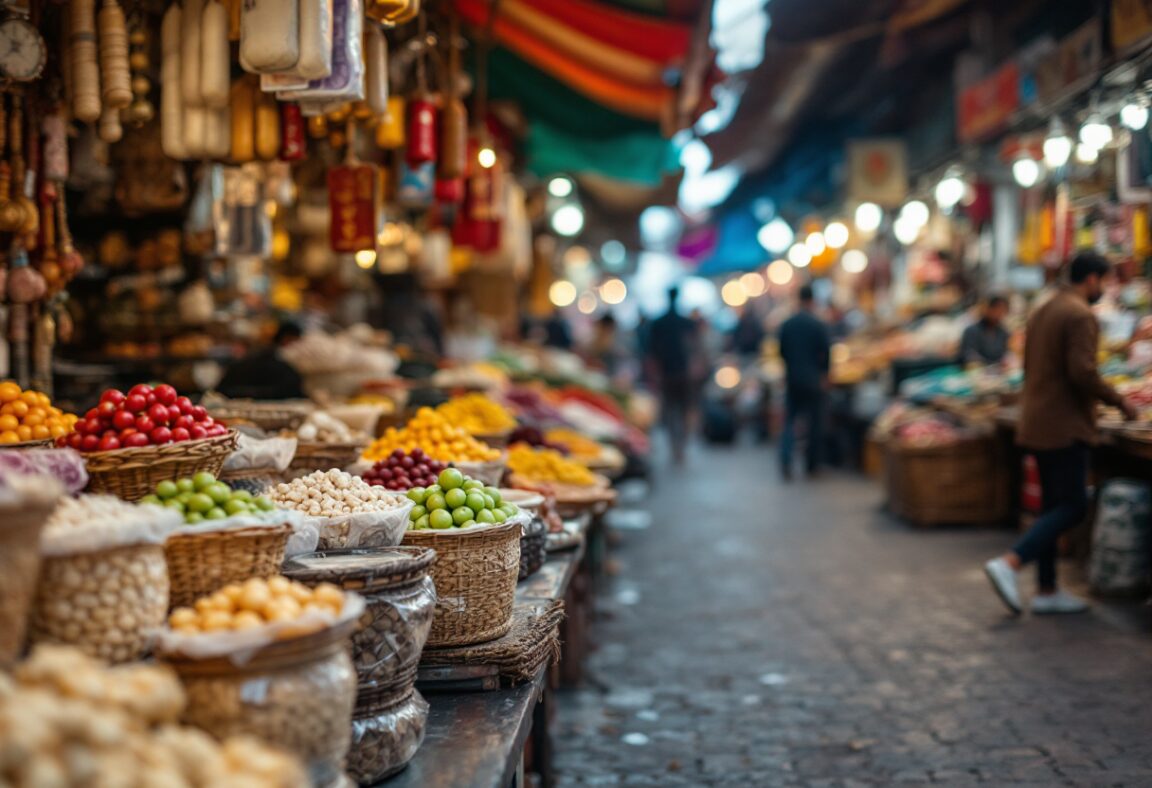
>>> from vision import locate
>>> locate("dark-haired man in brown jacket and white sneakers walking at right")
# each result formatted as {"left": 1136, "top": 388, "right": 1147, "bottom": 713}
{"left": 984, "top": 252, "right": 1136, "bottom": 614}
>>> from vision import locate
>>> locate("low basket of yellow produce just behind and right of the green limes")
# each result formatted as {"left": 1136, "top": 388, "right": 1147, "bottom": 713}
{"left": 508, "top": 444, "right": 616, "bottom": 516}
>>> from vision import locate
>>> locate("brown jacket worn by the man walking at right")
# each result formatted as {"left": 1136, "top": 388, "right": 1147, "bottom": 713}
{"left": 1016, "top": 289, "right": 1121, "bottom": 450}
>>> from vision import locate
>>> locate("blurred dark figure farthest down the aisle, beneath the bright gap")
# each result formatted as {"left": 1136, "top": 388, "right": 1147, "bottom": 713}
{"left": 647, "top": 287, "right": 699, "bottom": 465}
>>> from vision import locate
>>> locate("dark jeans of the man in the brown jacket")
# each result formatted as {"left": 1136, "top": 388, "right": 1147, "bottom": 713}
{"left": 1013, "top": 444, "right": 1090, "bottom": 591}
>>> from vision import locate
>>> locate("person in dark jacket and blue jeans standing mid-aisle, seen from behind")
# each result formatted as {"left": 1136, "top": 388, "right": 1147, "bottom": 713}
{"left": 779, "top": 285, "right": 832, "bottom": 479}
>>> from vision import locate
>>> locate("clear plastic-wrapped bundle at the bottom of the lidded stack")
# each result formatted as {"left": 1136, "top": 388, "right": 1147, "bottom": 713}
{"left": 348, "top": 690, "right": 429, "bottom": 785}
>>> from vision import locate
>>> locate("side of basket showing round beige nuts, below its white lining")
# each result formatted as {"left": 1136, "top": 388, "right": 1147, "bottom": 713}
{"left": 28, "top": 544, "right": 168, "bottom": 662}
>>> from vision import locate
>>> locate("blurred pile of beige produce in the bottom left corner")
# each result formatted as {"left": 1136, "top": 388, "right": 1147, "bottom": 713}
{"left": 0, "top": 646, "right": 311, "bottom": 788}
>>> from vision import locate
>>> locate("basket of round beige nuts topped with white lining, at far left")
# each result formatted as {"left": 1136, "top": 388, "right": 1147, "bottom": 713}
{"left": 28, "top": 495, "right": 182, "bottom": 662}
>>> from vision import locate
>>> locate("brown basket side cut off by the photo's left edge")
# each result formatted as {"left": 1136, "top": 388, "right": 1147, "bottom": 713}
{"left": 0, "top": 501, "right": 55, "bottom": 667}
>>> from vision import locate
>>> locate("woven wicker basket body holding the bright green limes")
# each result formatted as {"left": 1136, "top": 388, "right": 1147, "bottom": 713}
{"left": 403, "top": 522, "right": 521, "bottom": 649}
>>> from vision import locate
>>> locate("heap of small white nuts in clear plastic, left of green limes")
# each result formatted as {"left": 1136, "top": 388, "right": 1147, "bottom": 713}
{"left": 268, "top": 468, "right": 414, "bottom": 550}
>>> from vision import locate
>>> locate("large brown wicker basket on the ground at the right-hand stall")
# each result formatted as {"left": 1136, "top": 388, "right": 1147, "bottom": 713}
{"left": 884, "top": 435, "right": 1011, "bottom": 525}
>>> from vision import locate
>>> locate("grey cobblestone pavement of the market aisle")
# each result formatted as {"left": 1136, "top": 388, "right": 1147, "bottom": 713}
{"left": 555, "top": 448, "right": 1152, "bottom": 788}
